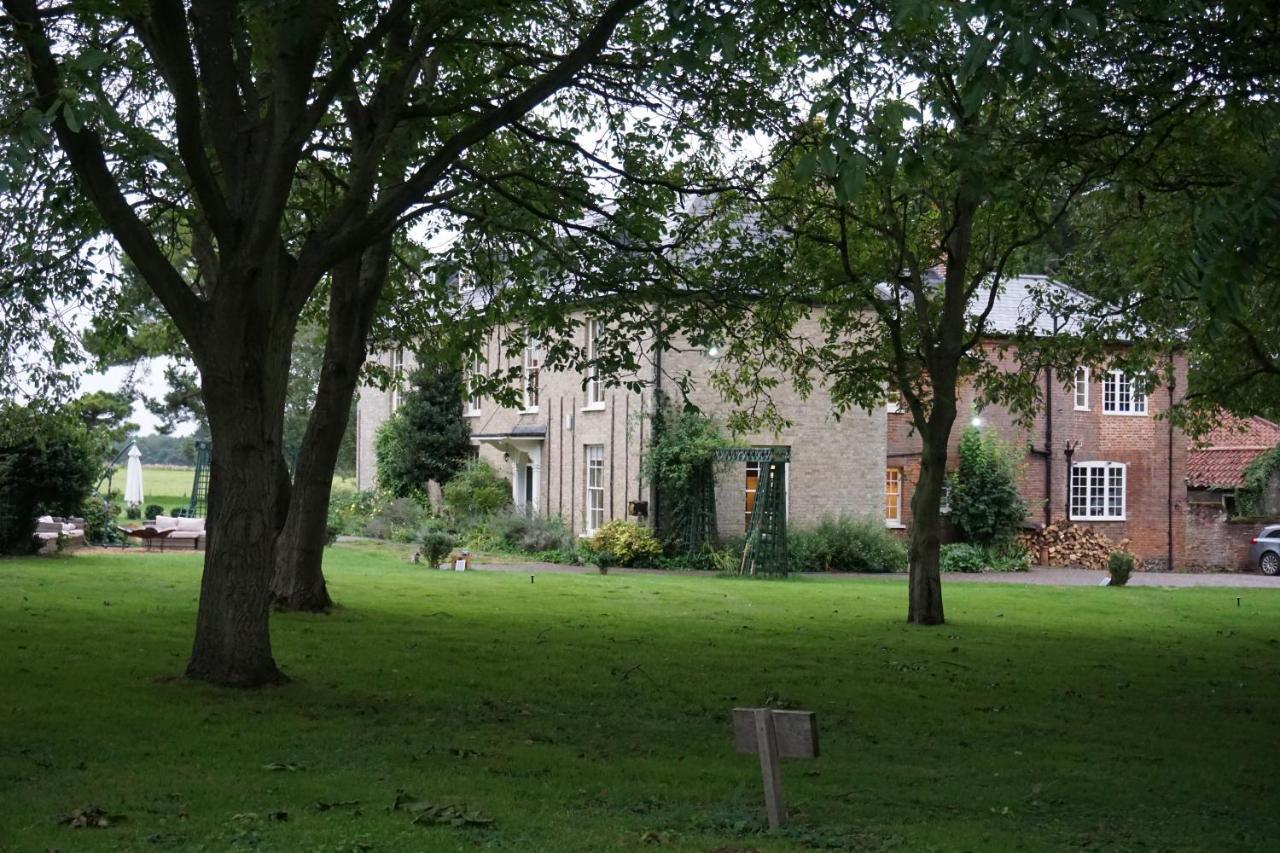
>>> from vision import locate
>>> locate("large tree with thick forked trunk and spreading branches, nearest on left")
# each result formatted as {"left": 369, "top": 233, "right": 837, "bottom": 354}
{"left": 3, "top": 0, "right": 675, "bottom": 686}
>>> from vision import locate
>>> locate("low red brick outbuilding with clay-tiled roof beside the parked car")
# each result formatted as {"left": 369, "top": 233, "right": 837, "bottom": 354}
{"left": 1187, "top": 415, "right": 1280, "bottom": 570}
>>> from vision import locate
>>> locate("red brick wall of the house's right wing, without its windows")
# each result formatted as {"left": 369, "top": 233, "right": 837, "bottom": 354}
{"left": 887, "top": 345, "right": 1187, "bottom": 567}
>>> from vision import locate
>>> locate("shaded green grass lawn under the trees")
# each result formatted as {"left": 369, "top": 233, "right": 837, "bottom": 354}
{"left": 0, "top": 546, "right": 1280, "bottom": 852}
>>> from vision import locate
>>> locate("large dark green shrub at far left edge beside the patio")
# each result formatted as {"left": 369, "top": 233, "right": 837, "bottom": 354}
{"left": 0, "top": 403, "right": 102, "bottom": 553}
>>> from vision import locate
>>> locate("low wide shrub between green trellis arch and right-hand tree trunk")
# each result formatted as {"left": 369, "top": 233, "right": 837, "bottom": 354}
{"left": 787, "top": 515, "right": 906, "bottom": 571}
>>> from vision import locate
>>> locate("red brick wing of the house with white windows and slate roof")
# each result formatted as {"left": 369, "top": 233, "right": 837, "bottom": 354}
{"left": 884, "top": 275, "right": 1187, "bottom": 569}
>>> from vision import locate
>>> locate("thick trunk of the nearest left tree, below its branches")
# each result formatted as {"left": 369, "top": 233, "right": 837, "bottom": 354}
{"left": 187, "top": 371, "right": 289, "bottom": 688}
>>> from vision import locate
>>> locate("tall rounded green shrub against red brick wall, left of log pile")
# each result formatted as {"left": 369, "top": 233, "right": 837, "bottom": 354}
{"left": 947, "top": 427, "right": 1027, "bottom": 546}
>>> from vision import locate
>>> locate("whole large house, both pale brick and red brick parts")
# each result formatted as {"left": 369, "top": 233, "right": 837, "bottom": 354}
{"left": 357, "top": 275, "right": 1187, "bottom": 567}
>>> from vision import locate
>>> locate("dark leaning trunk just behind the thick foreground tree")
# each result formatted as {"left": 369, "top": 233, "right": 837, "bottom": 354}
{"left": 271, "top": 245, "right": 389, "bottom": 612}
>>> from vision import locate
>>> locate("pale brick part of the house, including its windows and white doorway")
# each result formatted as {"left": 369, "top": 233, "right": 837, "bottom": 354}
{"left": 356, "top": 314, "right": 886, "bottom": 538}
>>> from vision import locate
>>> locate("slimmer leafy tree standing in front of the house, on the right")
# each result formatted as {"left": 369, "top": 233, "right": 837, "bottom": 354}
{"left": 691, "top": 0, "right": 1215, "bottom": 624}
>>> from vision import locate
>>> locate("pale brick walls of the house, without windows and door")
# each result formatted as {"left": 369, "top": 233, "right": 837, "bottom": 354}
{"left": 357, "top": 311, "right": 886, "bottom": 535}
